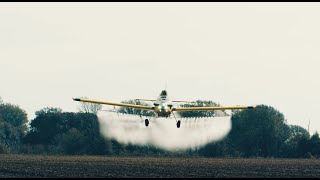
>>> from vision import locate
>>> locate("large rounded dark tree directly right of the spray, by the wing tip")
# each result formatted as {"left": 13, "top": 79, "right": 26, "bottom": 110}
{"left": 229, "top": 105, "right": 290, "bottom": 157}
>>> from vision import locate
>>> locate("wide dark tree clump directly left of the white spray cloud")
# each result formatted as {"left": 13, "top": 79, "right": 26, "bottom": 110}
{"left": 24, "top": 108, "right": 112, "bottom": 154}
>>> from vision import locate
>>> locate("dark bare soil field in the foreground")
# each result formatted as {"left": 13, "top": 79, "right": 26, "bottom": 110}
{"left": 0, "top": 154, "right": 320, "bottom": 178}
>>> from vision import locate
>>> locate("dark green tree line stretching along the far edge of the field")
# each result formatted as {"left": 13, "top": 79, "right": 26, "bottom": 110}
{"left": 0, "top": 99, "right": 320, "bottom": 158}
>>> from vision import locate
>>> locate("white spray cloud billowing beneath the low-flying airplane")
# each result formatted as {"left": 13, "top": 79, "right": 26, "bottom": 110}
{"left": 98, "top": 112, "right": 231, "bottom": 151}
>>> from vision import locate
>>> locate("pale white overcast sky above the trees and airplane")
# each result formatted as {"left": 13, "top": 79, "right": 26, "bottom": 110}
{"left": 0, "top": 2, "right": 320, "bottom": 133}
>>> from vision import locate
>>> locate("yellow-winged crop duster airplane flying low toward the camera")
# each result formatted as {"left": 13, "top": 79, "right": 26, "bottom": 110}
{"left": 73, "top": 90, "right": 256, "bottom": 128}
